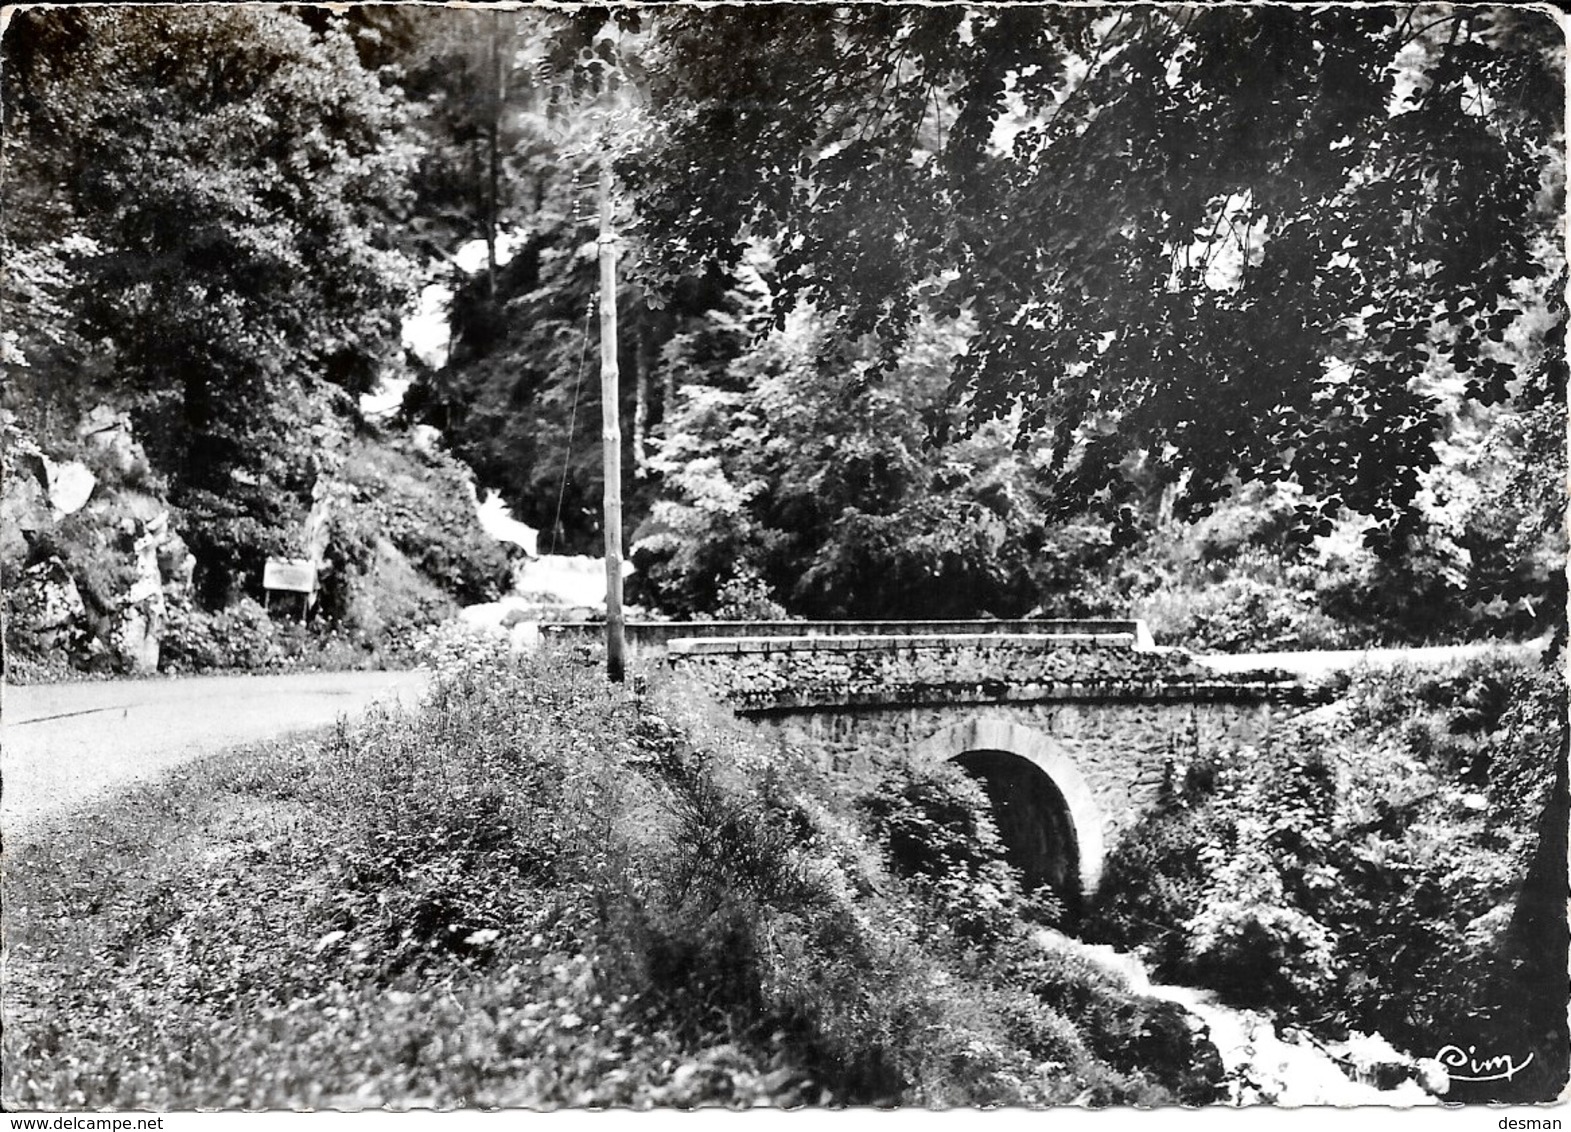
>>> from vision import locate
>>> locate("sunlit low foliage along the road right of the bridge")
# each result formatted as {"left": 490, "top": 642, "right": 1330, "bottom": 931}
{"left": 1093, "top": 471, "right": 1565, "bottom": 652}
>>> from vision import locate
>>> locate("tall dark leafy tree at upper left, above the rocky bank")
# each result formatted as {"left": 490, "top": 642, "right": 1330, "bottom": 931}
{"left": 5, "top": 6, "right": 412, "bottom": 603}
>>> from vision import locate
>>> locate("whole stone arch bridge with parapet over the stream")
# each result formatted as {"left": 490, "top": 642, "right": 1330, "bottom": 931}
{"left": 546, "top": 620, "right": 1315, "bottom": 907}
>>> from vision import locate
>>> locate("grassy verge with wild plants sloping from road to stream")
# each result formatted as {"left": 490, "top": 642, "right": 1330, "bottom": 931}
{"left": 3, "top": 640, "right": 1216, "bottom": 1108}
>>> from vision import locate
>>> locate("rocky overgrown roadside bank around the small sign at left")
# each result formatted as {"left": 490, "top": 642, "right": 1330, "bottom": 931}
{"left": 0, "top": 402, "right": 512, "bottom": 681}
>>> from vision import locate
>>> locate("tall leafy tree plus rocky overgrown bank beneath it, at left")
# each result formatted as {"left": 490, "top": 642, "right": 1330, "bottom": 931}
{"left": 0, "top": 6, "right": 530, "bottom": 675}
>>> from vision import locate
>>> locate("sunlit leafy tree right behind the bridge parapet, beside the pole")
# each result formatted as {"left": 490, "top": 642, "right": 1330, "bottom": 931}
{"left": 635, "top": 256, "right": 1048, "bottom": 617}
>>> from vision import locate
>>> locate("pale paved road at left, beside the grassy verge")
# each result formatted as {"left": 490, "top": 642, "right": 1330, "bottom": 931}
{"left": 0, "top": 672, "right": 430, "bottom": 834}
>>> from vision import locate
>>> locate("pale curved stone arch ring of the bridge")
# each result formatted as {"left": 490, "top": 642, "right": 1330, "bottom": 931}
{"left": 913, "top": 716, "right": 1103, "bottom": 898}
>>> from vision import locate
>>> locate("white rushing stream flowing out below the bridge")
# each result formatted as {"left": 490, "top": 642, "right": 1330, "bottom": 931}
{"left": 1037, "top": 929, "right": 1444, "bottom": 1108}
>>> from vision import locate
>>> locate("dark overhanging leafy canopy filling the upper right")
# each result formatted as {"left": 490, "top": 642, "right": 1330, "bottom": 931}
{"left": 624, "top": 5, "right": 1563, "bottom": 548}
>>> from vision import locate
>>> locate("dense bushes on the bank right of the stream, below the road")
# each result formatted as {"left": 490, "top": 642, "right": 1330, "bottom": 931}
{"left": 1087, "top": 661, "right": 1566, "bottom": 1101}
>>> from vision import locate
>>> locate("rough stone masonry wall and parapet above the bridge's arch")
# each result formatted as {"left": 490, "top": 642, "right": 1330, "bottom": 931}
{"left": 666, "top": 631, "right": 1310, "bottom": 848}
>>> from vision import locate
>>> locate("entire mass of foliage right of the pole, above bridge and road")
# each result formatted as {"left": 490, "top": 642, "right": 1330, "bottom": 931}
{"left": 596, "top": 6, "right": 1565, "bottom": 631}
